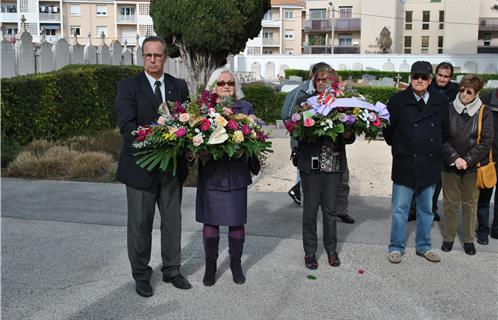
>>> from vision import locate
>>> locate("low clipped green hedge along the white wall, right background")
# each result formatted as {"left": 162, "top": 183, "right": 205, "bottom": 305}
{"left": 285, "top": 69, "right": 498, "bottom": 82}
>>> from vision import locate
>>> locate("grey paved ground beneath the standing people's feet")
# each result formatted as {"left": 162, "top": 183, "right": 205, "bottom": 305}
{"left": 1, "top": 179, "right": 498, "bottom": 320}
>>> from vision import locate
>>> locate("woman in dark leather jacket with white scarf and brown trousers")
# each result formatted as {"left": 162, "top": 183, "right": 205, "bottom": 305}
{"left": 441, "top": 75, "right": 493, "bottom": 255}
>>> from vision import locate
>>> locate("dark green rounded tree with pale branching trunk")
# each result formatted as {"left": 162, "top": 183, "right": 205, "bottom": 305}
{"left": 150, "top": 0, "right": 271, "bottom": 92}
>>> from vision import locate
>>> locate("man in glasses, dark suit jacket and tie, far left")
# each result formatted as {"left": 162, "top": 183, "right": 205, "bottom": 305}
{"left": 116, "top": 36, "right": 192, "bottom": 297}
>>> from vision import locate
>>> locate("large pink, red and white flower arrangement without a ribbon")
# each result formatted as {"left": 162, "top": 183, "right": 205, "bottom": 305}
{"left": 133, "top": 91, "right": 271, "bottom": 173}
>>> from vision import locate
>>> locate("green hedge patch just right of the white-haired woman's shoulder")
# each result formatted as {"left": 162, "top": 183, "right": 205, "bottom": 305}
{"left": 242, "top": 83, "right": 287, "bottom": 123}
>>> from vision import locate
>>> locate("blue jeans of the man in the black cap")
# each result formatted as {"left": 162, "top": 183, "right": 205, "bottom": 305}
{"left": 389, "top": 183, "right": 436, "bottom": 253}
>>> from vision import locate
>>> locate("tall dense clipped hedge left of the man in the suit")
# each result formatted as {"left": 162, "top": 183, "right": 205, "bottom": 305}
{"left": 1, "top": 65, "right": 142, "bottom": 145}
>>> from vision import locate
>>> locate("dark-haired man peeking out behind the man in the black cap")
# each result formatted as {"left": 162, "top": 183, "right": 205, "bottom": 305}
{"left": 408, "top": 62, "right": 459, "bottom": 221}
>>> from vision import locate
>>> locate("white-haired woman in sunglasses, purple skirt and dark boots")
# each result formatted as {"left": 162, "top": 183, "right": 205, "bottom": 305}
{"left": 196, "top": 68, "right": 257, "bottom": 286}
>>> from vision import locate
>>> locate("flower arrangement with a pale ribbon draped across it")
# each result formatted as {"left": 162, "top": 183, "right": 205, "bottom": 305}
{"left": 285, "top": 82, "right": 389, "bottom": 141}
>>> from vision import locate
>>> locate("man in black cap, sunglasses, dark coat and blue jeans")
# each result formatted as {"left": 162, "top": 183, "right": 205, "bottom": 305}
{"left": 383, "top": 61, "right": 449, "bottom": 263}
